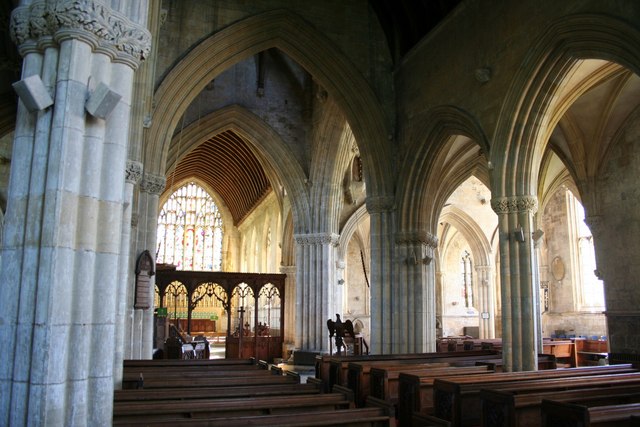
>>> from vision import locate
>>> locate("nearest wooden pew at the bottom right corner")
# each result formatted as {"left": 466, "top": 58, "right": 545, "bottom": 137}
{"left": 542, "top": 400, "right": 640, "bottom": 427}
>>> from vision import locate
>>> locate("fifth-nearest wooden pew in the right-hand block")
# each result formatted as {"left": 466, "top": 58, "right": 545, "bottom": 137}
{"left": 369, "top": 365, "right": 492, "bottom": 403}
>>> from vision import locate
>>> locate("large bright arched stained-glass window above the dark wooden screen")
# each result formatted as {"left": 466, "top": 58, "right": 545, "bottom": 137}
{"left": 156, "top": 182, "right": 222, "bottom": 271}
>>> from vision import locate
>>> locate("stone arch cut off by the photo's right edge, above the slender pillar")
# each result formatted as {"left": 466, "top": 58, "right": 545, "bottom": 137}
{"left": 491, "top": 14, "right": 640, "bottom": 197}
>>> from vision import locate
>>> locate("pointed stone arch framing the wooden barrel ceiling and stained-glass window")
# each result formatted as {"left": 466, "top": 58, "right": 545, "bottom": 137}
{"left": 163, "top": 105, "right": 310, "bottom": 234}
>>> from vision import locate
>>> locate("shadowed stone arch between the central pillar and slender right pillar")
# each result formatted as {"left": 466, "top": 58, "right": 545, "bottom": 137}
{"left": 397, "top": 105, "right": 489, "bottom": 234}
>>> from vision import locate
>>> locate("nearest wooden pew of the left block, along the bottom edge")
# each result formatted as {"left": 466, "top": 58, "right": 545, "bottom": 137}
{"left": 114, "top": 408, "right": 395, "bottom": 427}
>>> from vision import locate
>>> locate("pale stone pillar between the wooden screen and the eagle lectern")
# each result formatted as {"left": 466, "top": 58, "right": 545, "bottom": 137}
{"left": 294, "top": 233, "right": 342, "bottom": 353}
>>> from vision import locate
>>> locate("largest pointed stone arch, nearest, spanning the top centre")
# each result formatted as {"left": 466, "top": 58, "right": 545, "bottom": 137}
{"left": 144, "top": 10, "right": 393, "bottom": 200}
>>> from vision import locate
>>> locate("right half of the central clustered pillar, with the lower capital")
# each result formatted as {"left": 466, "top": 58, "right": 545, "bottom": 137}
{"left": 392, "top": 232, "right": 438, "bottom": 353}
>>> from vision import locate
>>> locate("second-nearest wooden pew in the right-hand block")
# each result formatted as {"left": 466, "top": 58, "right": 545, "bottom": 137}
{"left": 480, "top": 384, "right": 640, "bottom": 427}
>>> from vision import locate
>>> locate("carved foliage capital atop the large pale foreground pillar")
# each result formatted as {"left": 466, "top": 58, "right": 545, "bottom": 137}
{"left": 10, "top": 0, "right": 151, "bottom": 68}
